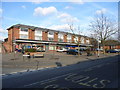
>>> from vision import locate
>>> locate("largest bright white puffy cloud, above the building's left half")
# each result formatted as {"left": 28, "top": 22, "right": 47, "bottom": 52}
{"left": 33, "top": 6, "right": 57, "bottom": 16}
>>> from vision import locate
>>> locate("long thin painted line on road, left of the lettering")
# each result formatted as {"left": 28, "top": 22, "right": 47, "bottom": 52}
{"left": 24, "top": 73, "right": 72, "bottom": 87}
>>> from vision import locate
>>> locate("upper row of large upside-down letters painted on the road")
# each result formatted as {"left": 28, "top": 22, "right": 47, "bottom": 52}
{"left": 65, "top": 74, "right": 111, "bottom": 88}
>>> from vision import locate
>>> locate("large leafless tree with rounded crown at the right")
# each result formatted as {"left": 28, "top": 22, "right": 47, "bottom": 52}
{"left": 90, "top": 12, "right": 118, "bottom": 53}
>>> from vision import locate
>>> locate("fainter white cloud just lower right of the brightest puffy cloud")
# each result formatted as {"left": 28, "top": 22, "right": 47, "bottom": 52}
{"left": 58, "top": 13, "right": 79, "bottom": 23}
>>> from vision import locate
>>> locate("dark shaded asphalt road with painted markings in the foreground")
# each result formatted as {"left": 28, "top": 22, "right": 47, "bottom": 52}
{"left": 2, "top": 55, "right": 120, "bottom": 90}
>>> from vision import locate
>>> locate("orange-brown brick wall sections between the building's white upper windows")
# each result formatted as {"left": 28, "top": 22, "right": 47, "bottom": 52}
{"left": 3, "top": 24, "right": 90, "bottom": 52}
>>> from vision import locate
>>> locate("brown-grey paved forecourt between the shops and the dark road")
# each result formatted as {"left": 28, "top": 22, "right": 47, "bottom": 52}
{"left": 2, "top": 51, "right": 117, "bottom": 74}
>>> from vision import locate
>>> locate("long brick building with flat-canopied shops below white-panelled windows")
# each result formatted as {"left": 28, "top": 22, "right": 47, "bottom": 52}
{"left": 3, "top": 24, "right": 92, "bottom": 52}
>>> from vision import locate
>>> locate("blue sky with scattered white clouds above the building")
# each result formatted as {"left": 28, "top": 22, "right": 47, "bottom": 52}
{"left": 0, "top": 0, "right": 118, "bottom": 40}
